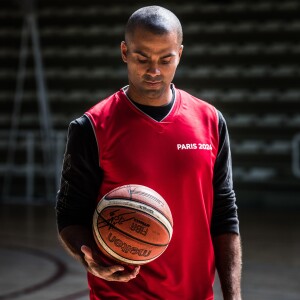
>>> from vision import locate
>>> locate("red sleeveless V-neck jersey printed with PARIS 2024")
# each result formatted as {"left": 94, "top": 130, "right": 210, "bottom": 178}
{"left": 86, "top": 85, "right": 219, "bottom": 300}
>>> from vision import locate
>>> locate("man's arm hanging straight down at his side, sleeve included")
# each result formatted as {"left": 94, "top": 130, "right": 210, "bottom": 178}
{"left": 211, "top": 113, "right": 241, "bottom": 300}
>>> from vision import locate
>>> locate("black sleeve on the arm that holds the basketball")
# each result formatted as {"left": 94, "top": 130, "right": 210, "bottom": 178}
{"left": 55, "top": 116, "right": 102, "bottom": 231}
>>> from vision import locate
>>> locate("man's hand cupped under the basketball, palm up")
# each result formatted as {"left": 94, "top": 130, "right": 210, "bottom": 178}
{"left": 81, "top": 246, "right": 140, "bottom": 282}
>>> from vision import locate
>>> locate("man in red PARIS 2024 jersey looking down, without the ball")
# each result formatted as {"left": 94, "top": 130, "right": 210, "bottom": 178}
{"left": 56, "top": 6, "right": 241, "bottom": 300}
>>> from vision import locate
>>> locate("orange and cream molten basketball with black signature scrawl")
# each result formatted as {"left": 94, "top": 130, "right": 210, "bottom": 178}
{"left": 93, "top": 184, "right": 173, "bottom": 265}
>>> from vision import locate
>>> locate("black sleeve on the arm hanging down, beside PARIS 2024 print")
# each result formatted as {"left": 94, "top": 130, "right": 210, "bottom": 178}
{"left": 211, "top": 111, "right": 239, "bottom": 236}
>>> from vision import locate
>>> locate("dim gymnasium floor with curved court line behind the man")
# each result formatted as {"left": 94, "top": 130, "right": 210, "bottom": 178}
{"left": 0, "top": 205, "right": 300, "bottom": 300}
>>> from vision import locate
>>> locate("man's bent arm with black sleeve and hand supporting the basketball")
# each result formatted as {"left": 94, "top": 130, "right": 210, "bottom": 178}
{"left": 56, "top": 117, "right": 139, "bottom": 282}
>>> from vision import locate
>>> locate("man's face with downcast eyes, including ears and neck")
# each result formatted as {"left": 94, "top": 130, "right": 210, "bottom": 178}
{"left": 121, "top": 28, "right": 183, "bottom": 106}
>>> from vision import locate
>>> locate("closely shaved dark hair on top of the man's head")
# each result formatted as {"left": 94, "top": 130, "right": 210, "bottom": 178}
{"left": 125, "top": 6, "right": 183, "bottom": 45}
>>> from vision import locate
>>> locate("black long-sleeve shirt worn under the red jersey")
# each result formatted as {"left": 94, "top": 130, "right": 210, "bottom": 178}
{"left": 56, "top": 97, "right": 239, "bottom": 236}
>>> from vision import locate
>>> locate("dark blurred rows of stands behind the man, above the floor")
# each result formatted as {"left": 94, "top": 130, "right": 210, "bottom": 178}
{"left": 0, "top": 0, "right": 300, "bottom": 208}
